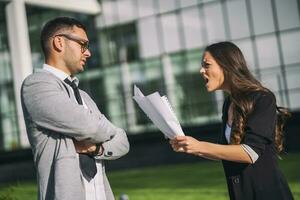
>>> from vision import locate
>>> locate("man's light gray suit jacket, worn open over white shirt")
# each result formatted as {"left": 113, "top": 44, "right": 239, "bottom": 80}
{"left": 21, "top": 70, "right": 129, "bottom": 200}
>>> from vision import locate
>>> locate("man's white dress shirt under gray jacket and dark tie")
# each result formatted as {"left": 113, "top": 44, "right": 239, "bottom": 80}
{"left": 43, "top": 64, "right": 106, "bottom": 200}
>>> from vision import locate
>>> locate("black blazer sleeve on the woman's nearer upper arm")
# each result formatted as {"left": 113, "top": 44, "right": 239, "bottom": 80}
{"left": 241, "top": 93, "right": 276, "bottom": 156}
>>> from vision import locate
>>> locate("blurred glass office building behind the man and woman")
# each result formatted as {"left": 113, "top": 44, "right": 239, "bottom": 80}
{"left": 0, "top": 0, "right": 300, "bottom": 151}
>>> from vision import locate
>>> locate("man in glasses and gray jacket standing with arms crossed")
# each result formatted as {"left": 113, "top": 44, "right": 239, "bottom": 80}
{"left": 21, "top": 17, "right": 129, "bottom": 200}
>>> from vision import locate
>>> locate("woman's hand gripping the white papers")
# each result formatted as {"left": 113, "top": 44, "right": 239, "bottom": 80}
{"left": 170, "top": 136, "right": 201, "bottom": 155}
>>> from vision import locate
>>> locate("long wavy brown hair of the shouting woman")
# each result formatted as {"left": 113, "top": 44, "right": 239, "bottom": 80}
{"left": 205, "top": 42, "right": 290, "bottom": 153}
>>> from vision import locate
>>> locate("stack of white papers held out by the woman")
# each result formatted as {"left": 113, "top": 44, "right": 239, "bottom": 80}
{"left": 133, "top": 86, "right": 184, "bottom": 139}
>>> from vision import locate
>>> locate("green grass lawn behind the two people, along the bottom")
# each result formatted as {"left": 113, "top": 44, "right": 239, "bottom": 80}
{"left": 0, "top": 153, "right": 300, "bottom": 200}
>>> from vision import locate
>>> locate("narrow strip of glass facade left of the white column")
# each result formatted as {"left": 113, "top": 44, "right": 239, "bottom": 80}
{"left": 0, "top": 2, "right": 20, "bottom": 151}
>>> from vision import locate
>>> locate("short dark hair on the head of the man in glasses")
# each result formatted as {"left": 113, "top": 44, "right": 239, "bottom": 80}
{"left": 41, "top": 17, "right": 86, "bottom": 58}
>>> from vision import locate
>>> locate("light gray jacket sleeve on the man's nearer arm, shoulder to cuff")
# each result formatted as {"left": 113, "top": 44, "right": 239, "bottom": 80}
{"left": 21, "top": 75, "right": 116, "bottom": 143}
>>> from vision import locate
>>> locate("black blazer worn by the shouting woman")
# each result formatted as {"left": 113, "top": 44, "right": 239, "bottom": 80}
{"left": 219, "top": 92, "right": 293, "bottom": 200}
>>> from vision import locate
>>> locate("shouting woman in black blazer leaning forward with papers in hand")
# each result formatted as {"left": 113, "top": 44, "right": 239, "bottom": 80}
{"left": 170, "top": 42, "right": 293, "bottom": 200}
